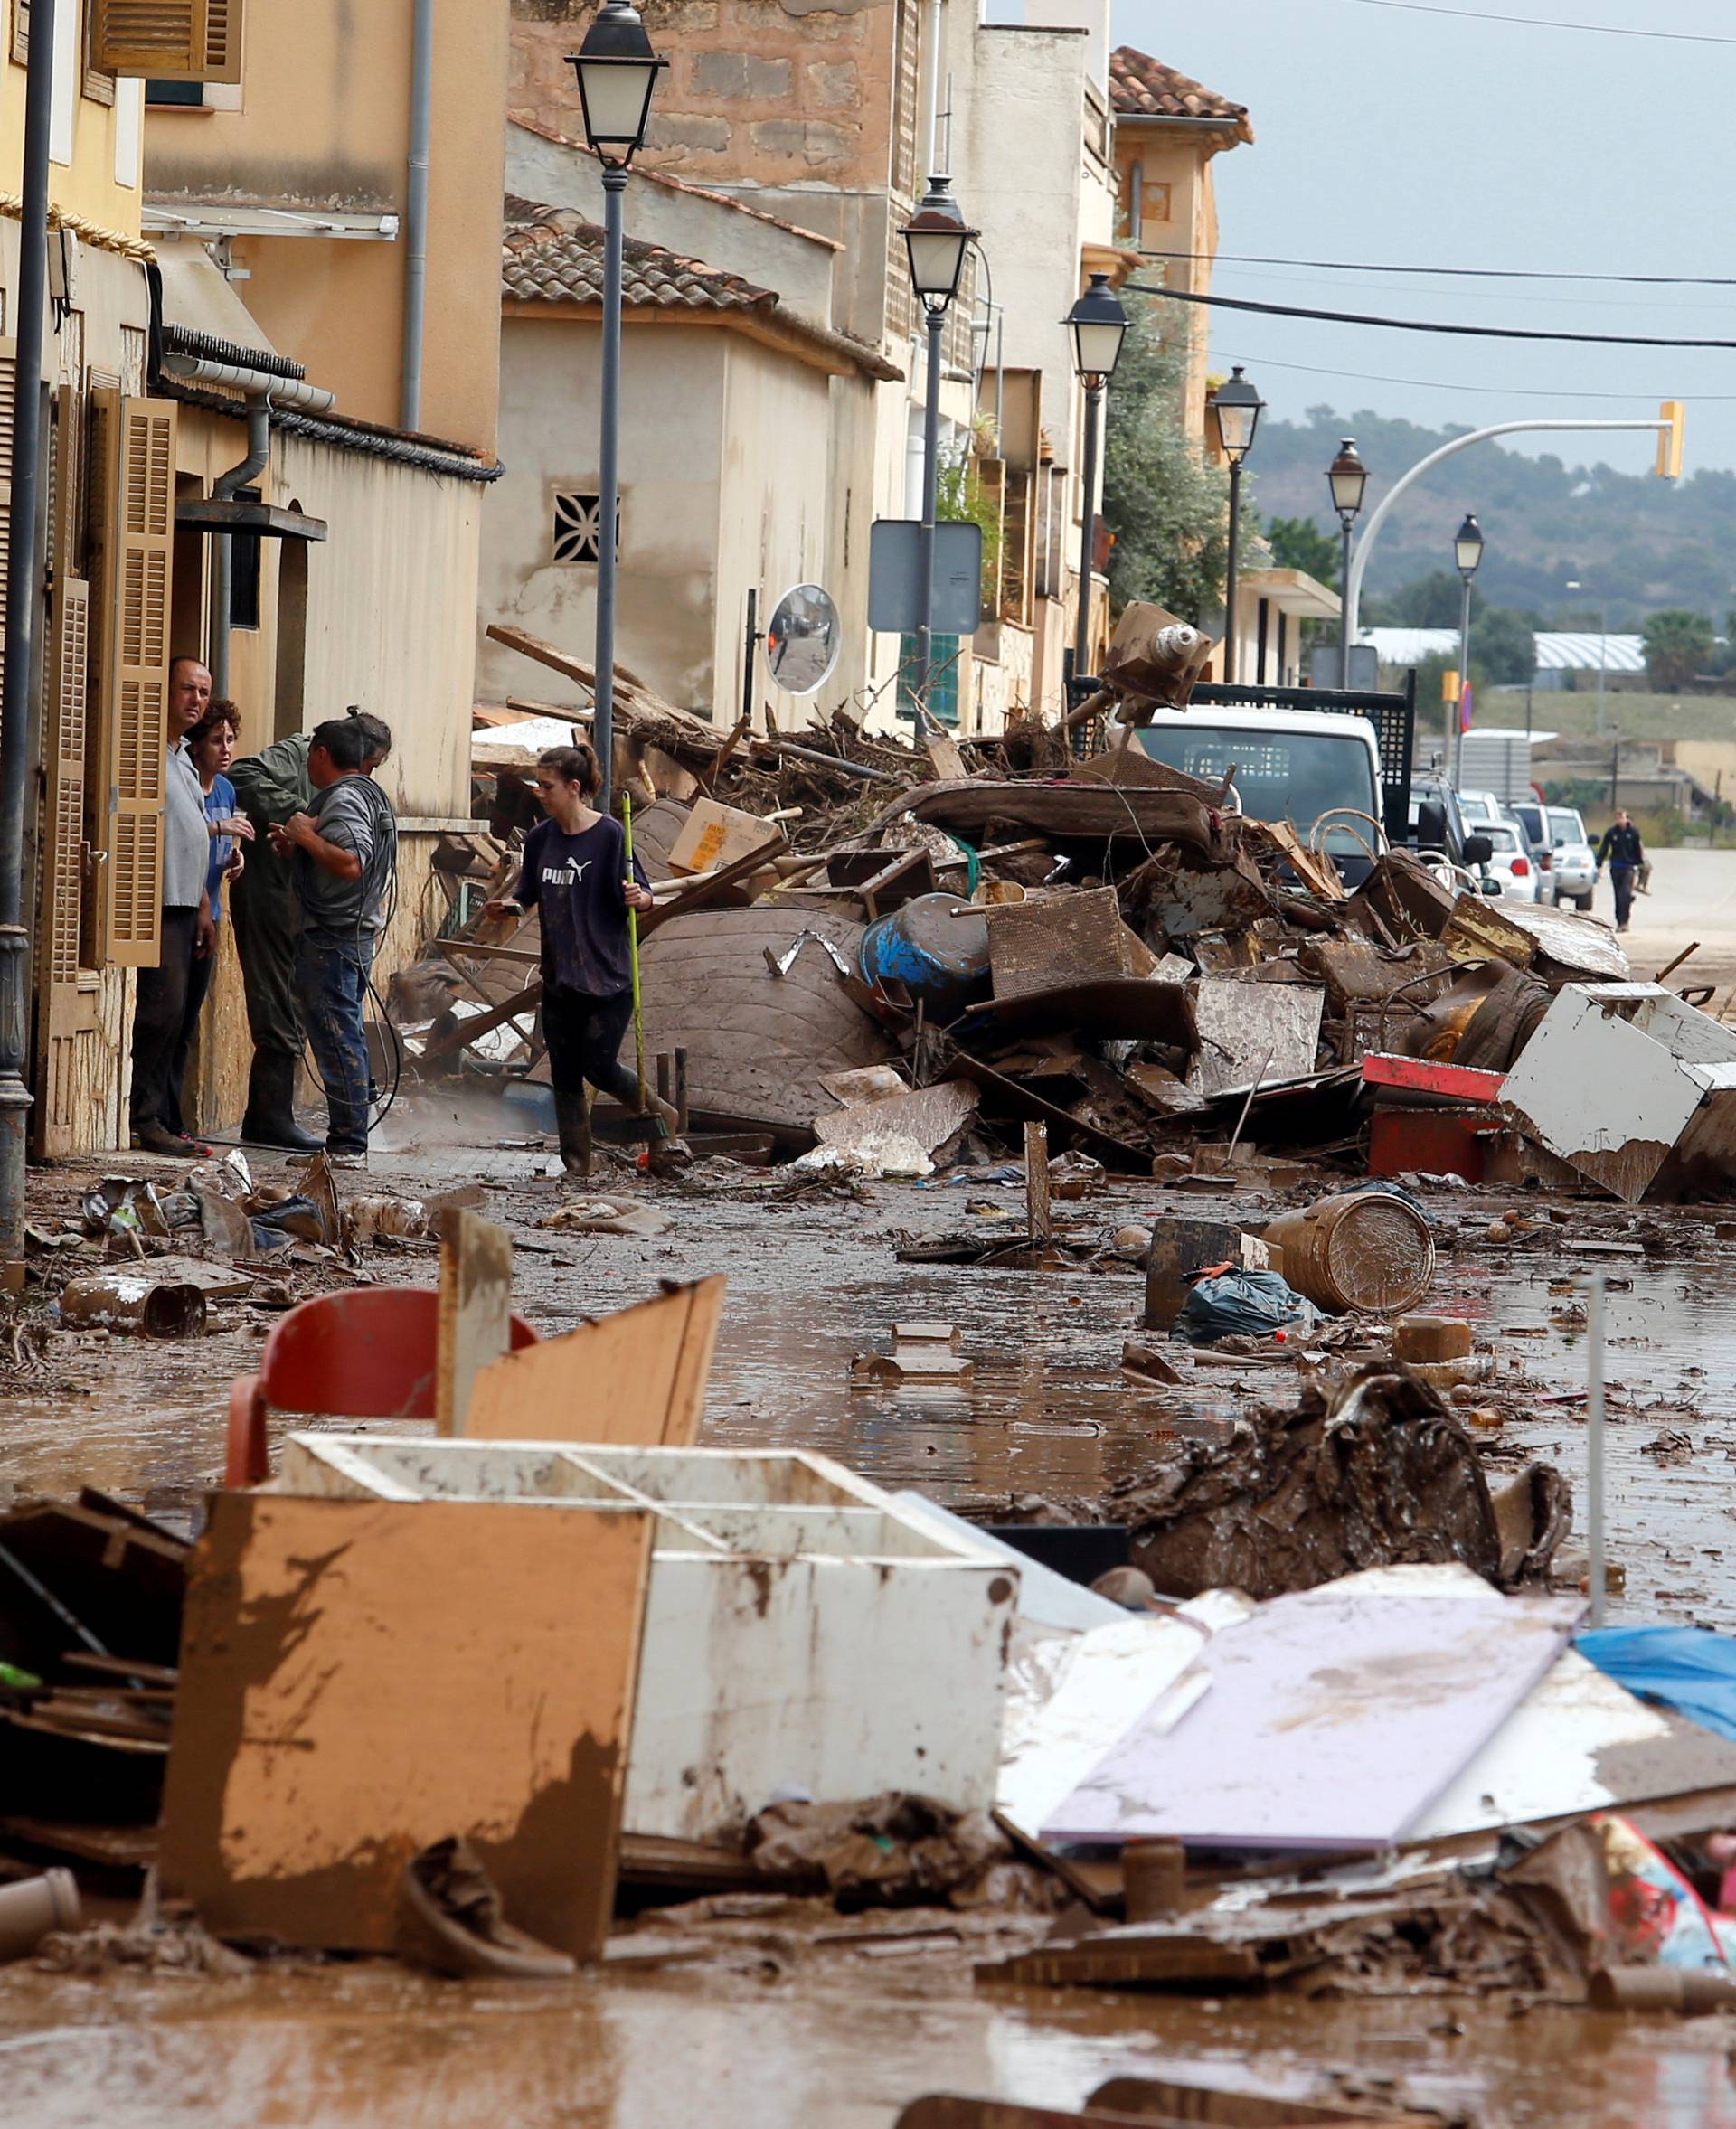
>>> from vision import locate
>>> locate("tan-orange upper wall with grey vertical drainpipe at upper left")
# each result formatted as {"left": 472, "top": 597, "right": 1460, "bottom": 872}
{"left": 145, "top": 0, "right": 507, "bottom": 449}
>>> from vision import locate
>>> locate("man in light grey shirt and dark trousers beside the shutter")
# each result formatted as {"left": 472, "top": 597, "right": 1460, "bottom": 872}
{"left": 132, "top": 658, "right": 217, "bottom": 1160}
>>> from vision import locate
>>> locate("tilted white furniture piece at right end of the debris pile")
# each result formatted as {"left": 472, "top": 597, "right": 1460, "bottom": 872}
{"left": 1502, "top": 984, "right": 1736, "bottom": 1205}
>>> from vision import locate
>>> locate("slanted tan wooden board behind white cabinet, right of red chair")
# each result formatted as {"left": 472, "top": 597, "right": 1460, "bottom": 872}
{"left": 465, "top": 1277, "right": 726, "bottom": 1450}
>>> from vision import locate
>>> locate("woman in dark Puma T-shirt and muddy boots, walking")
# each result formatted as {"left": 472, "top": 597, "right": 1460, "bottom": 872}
{"left": 487, "top": 741, "right": 686, "bottom": 1182}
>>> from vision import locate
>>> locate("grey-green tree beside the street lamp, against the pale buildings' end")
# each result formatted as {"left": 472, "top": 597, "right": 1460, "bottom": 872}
{"left": 1103, "top": 298, "right": 1229, "bottom": 626}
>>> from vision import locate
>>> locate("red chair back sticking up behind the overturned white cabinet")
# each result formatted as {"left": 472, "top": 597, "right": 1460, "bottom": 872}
{"left": 223, "top": 1286, "right": 537, "bottom": 1486}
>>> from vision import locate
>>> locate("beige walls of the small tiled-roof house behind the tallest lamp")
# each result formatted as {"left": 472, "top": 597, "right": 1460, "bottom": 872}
{"left": 477, "top": 308, "right": 847, "bottom": 724}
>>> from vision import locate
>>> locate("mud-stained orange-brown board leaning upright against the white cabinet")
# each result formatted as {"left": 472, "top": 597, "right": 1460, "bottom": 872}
{"left": 162, "top": 1493, "right": 654, "bottom": 1959}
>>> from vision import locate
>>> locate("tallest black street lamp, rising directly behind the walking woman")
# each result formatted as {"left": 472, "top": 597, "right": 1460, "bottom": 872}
{"left": 567, "top": 0, "right": 669, "bottom": 814}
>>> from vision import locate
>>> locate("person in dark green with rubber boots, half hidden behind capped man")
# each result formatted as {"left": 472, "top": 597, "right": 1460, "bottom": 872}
{"left": 230, "top": 711, "right": 392, "bottom": 1154}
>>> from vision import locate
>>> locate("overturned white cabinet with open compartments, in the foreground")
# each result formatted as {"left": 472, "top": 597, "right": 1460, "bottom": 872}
{"left": 262, "top": 1435, "right": 1018, "bottom": 1839}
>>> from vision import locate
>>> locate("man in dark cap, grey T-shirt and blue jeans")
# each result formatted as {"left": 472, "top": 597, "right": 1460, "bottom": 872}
{"left": 270, "top": 718, "right": 399, "bottom": 1169}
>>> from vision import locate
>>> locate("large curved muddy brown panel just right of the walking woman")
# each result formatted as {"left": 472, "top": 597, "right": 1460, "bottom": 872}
{"left": 641, "top": 905, "right": 897, "bottom": 1141}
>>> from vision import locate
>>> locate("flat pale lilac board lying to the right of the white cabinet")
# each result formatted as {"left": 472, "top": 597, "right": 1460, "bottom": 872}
{"left": 1042, "top": 1578, "right": 1585, "bottom": 1848}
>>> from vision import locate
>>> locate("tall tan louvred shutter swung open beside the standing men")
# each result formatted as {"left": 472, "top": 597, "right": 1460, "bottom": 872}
{"left": 96, "top": 394, "right": 175, "bottom": 969}
